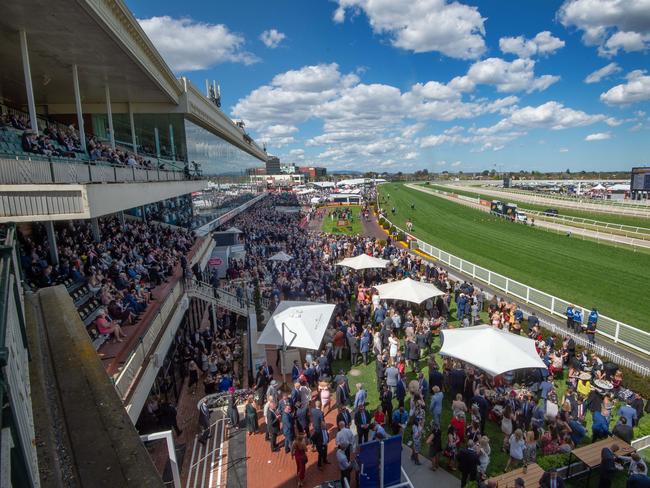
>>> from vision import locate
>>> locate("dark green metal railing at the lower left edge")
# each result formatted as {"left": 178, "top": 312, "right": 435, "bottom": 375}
{"left": 0, "top": 226, "right": 40, "bottom": 487}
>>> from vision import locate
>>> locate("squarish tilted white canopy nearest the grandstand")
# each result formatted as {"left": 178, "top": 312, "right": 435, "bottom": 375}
{"left": 257, "top": 301, "right": 336, "bottom": 350}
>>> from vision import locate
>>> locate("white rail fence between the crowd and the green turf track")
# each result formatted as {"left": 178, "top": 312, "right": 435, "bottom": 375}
{"left": 386, "top": 215, "right": 650, "bottom": 360}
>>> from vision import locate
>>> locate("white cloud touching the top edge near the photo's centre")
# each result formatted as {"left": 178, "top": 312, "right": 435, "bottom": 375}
{"left": 333, "top": 0, "right": 485, "bottom": 59}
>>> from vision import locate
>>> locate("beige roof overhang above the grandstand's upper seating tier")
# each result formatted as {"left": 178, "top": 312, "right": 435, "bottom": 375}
{"left": 0, "top": 0, "right": 182, "bottom": 104}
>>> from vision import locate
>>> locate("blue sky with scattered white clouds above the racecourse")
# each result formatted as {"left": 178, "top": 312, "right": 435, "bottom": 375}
{"left": 127, "top": 0, "right": 650, "bottom": 172}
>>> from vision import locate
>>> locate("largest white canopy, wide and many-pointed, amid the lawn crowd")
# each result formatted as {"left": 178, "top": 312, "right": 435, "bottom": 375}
{"left": 440, "top": 325, "right": 546, "bottom": 376}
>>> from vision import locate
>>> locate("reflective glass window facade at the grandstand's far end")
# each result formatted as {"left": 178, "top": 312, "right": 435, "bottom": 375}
{"left": 184, "top": 120, "right": 264, "bottom": 179}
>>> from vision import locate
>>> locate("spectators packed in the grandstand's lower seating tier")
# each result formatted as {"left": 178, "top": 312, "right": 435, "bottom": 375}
{"left": 20, "top": 218, "right": 195, "bottom": 342}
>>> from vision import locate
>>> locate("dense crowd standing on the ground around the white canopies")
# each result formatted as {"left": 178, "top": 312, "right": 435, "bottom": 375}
{"left": 215, "top": 197, "right": 650, "bottom": 486}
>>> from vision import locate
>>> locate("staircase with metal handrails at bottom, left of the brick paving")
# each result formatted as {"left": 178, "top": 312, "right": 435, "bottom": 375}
{"left": 185, "top": 410, "right": 228, "bottom": 488}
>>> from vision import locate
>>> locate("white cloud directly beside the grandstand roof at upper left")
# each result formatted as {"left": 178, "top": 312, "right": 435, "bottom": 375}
{"left": 138, "top": 15, "right": 257, "bottom": 72}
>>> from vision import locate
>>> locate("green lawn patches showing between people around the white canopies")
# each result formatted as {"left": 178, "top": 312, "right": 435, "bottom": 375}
{"left": 333, "top": 302, "right": 650, "bottom": 488}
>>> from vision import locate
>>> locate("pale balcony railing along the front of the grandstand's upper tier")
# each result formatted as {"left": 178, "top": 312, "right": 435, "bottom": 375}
{"left": 0, "top": 158, "right": 187, "bottom": 185}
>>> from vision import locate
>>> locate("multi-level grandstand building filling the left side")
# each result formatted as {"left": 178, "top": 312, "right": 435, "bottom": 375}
{"left": 0, "top": 0, "right": 267, "bottom": 487}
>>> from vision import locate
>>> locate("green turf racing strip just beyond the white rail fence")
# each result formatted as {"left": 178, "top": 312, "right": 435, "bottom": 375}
{"left": 379, "top": 184, "right": 650, "bottom": 330}
